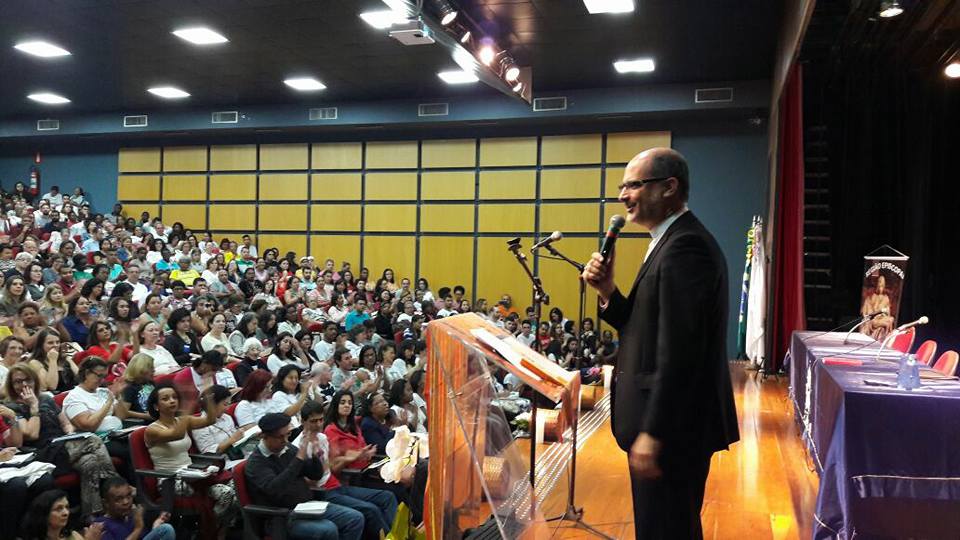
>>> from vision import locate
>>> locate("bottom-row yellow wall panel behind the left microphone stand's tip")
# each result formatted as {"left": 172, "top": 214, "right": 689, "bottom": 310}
{"left": 478, "top": 237, "right": 532, "bottom": 316}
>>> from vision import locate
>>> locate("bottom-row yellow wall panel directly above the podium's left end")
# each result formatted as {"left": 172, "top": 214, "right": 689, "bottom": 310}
{"left": 420, "top": 236, "right": 473, "bottom": 292}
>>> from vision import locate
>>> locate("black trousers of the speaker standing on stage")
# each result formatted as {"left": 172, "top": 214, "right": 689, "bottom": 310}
{"left": 630, "top": 454, "right": 711, "bottom": 540}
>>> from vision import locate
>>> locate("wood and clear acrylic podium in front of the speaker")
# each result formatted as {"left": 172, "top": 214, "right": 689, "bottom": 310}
{"left": 424, "top": 313, "right": 580, "bottom": 540}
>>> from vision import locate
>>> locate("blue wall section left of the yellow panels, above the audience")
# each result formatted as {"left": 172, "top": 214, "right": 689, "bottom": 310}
{"left": 0, "top": 150, "right": 117, "bottom": 213}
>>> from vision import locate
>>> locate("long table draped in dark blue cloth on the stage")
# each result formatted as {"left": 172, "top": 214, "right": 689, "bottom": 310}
{"left": 790, "top": 332, "right": 960, "bottom": 539}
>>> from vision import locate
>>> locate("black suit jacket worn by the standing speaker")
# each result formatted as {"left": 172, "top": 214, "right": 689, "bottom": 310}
{"left": 601, "top": 211, "right": 740, "bottom": 455}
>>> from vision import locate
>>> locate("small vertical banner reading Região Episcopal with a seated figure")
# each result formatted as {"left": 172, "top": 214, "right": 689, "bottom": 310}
{"left": 860, "top": 246, "right": 910, "bottom": 341}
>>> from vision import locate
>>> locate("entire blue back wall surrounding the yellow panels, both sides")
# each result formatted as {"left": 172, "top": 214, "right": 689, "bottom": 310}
{"left": 0, "top": 117, "right": 767, "bottom": 358}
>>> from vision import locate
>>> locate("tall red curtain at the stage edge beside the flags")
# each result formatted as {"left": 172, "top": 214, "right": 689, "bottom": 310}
{"left": 767, "top": 63, "right": 806, "bottom": 370}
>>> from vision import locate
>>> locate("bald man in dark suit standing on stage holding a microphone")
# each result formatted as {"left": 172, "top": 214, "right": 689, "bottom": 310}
{"left": 583, "top": 148, "right": 739, "bottom": 540}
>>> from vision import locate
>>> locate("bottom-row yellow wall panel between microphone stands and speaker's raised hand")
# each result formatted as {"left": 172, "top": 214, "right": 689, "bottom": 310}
{"left": 536, "top": 238, "right": 596, "bottom": 323}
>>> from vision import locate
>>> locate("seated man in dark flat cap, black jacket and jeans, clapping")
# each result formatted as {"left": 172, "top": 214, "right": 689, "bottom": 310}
{"left": 245, "top": 413, "right": 364, "bottom": 540}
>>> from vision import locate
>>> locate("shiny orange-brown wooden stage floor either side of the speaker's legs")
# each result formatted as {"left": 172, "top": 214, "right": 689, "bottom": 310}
{"left": 553, "top": 363, "right": 817, "bottom": 540}
